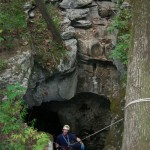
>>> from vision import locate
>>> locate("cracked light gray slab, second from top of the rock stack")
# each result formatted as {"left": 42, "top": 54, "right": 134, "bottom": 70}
{"left": 66, "top": 8, "right": 89, "bottom": 21}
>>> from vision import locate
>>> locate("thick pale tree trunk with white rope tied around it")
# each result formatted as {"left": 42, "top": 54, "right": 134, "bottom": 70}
{"left": 122, "top": 0, "right": 150, "bottom": 150}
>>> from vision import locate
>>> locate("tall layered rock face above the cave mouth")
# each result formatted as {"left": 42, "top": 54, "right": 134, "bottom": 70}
{"left": 26, "top": 0, "right": 120, "bottom": 107}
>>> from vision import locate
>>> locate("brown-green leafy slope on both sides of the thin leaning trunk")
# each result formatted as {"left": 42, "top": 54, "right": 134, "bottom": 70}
{"left": 29, "top": 4, "right": 66, "bottom": 71}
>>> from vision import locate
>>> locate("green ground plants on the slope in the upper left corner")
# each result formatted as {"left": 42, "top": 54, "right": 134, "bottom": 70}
{"left": 0, "top": 0, "right": 27, "bottom": 49}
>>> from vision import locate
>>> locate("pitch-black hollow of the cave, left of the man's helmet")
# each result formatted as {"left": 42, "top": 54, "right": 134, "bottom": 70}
{"left": 26, "top": 103, "right": 62, "bottom": 138}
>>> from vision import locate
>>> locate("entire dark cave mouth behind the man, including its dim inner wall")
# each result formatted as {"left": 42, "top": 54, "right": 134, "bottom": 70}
{"left": 26, "top": 92, "right": 111, "bottom": 150}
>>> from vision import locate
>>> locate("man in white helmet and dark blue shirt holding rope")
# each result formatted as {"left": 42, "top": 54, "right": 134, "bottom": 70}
{"left": 56, "top": 125, "right": 84, "bottom": 150}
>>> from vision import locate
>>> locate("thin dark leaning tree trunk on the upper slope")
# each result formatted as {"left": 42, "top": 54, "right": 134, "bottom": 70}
{"left": 35, "top": 0, "right": 63, "bottom": 45}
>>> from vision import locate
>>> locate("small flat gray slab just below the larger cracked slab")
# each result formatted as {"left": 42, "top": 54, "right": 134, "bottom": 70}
{"left": 72, "top": 20, "right": 92, "bottom": 29}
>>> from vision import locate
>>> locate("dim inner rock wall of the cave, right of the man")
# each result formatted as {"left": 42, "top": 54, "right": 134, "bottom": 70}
{"left": 50, "top": 93, "right": 111, "bottom": 150}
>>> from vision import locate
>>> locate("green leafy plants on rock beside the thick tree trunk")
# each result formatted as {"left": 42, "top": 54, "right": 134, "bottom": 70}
{"left": 108, "top": 1, "right": 131, "bottom": 64}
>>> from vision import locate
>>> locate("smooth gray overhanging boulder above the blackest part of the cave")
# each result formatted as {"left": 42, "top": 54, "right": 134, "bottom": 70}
{"left": 25, "top": 68, "right": 77, "bottom": 107}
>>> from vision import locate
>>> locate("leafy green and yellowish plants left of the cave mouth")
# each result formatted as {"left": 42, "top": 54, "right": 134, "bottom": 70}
{"left": 0, "top": 84, "right": 51, "bottom": 150}
